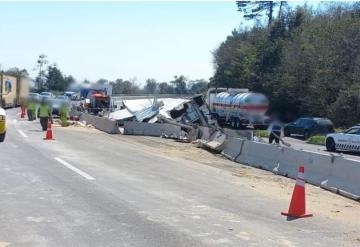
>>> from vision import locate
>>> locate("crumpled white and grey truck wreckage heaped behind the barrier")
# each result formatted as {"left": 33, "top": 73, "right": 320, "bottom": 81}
{"left": 109, "top": 95, "right": 217, "bottom": 141}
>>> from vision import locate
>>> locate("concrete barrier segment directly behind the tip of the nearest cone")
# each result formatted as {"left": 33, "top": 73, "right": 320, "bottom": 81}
{"left": 274, "top": 147, "right": 333, "bottom": 186}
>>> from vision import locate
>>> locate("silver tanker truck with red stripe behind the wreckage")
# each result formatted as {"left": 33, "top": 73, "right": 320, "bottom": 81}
{"left": 206, "top": 88, "right": 269, "bottom": 129}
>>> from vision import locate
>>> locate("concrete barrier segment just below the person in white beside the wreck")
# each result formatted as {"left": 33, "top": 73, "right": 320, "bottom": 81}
{"left": 235, "top": 140, "right": 283, "bottom": 171}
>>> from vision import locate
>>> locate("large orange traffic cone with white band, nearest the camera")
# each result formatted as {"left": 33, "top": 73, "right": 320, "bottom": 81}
{"left": 281, "top": 166, "right": 312, "bottom": 218}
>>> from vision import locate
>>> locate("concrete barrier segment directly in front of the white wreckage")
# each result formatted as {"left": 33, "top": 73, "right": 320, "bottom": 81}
{"left": 124, "top": 121, "right": 181, "bottom": 138}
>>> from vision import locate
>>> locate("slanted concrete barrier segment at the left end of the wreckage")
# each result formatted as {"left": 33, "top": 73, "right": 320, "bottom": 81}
{"left": 80, "top": 113, "right": 120, "bottom": 134}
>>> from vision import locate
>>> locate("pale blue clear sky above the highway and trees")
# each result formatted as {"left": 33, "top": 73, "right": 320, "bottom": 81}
{"left": 0, "top": 1, "right": 248, "bottom": 84}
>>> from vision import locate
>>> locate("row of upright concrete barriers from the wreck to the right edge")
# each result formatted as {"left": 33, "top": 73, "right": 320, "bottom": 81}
{"left": 229, "top": 140, "right": 360, "bottom": 200}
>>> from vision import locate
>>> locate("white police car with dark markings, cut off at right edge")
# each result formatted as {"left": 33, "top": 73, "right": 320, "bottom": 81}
{"left": 325, "top": 124, "right": 360, "bottom": 152}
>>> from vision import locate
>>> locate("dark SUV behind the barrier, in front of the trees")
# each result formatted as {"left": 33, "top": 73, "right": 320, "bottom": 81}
{"left": 284, "top": 117, "right": 335, "bottom": 139}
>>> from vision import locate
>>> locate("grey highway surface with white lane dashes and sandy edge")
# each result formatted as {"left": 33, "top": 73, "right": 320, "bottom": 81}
{"left": 0, "top": 109, "right": 360, "bottom": 247}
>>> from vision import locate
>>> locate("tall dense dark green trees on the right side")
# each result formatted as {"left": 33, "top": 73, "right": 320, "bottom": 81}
{"left": 210, "top": 1, "right": 360, "bottom": 126}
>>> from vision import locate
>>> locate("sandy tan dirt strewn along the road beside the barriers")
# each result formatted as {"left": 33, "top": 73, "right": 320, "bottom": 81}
{"left": 68, "top": 124, "right": 360, "bottom": 238}
